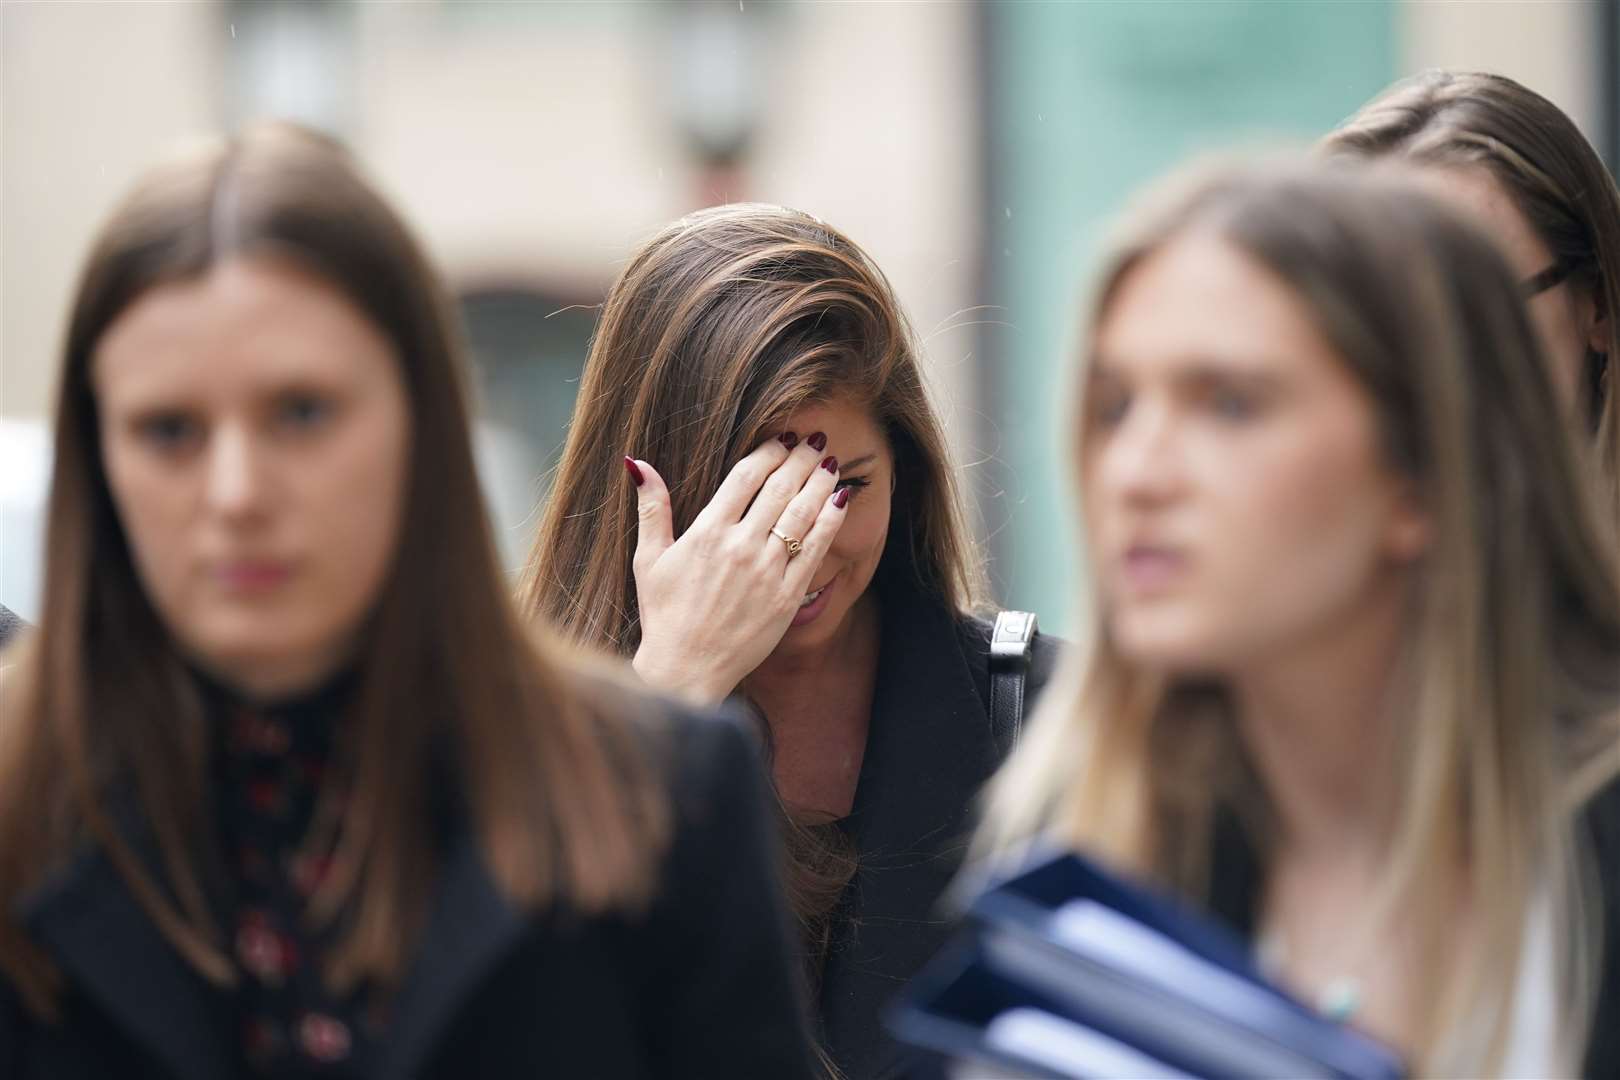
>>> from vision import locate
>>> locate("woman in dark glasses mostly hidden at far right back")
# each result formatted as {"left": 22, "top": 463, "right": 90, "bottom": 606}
{"left": 1322, "top": 71, "right": 1620, "bottom": 520}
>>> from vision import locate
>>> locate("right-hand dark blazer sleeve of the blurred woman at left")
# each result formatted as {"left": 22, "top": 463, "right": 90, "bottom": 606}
{"left": 648, "top": 717, "right": 812, "bottom": 1080}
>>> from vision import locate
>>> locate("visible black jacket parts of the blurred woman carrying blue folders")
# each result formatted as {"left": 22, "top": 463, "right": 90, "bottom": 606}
{"left": 1209, "top": 780, "right": 1620, "bottom": 1080}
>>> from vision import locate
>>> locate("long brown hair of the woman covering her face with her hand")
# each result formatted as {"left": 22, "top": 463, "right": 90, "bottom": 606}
{"left": 518, "top": 204, "right": 985, "bottom": 952}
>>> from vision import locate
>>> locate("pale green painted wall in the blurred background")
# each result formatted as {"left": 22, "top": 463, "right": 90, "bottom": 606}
{"left": 977, "top": 0, "right": 1396, "bottom": 633}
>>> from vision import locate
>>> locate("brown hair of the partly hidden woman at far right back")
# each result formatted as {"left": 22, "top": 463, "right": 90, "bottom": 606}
{"left": 1322, "top": 71, "right": 1620, "bottom": 515}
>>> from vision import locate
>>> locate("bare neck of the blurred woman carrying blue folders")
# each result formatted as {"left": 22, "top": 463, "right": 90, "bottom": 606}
{"left": 1231, "top": 581, "right": 1408, "bottom": 858}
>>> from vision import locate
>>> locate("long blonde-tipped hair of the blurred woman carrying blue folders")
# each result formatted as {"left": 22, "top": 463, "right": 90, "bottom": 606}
{"left": 978, "top": 162, "right": 1620, "bottom": 1075}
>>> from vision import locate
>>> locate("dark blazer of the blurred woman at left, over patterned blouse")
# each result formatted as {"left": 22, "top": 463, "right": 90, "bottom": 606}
{"left": 0, "top": 717, "right": 810, "bottom": 1080}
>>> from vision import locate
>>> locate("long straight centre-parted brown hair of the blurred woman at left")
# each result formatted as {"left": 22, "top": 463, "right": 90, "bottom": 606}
{"left": 0, "top": 125, "right": 667, "bottom": 1017}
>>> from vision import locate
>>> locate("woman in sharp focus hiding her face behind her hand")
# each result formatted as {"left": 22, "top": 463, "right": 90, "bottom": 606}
{"left": 522, "top": 206, "right": 1069, "bottom": 1078}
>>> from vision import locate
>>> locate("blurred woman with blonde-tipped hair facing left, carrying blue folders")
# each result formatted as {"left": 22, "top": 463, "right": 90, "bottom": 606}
{"left": 985, "top": 167, "right": 1620, "bottom": 1077}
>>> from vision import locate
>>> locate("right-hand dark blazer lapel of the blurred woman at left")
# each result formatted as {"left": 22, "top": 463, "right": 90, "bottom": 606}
{"left": 381, "top": 831, "right": 530, "bottom": 1078}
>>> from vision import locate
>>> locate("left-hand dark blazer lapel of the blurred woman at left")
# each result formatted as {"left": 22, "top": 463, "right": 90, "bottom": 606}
{"left": 18, "top": 814, "right": 237, "bottom": 1080}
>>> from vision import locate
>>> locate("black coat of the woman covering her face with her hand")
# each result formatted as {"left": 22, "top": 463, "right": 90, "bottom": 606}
{"left": 820, "top": 575, "right": 1061, "bottom": 1080}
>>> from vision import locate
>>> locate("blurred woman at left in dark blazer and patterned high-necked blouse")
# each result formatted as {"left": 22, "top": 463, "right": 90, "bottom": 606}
{"left": 0, "top": 126, "right": 810, "bottom": 1080}
